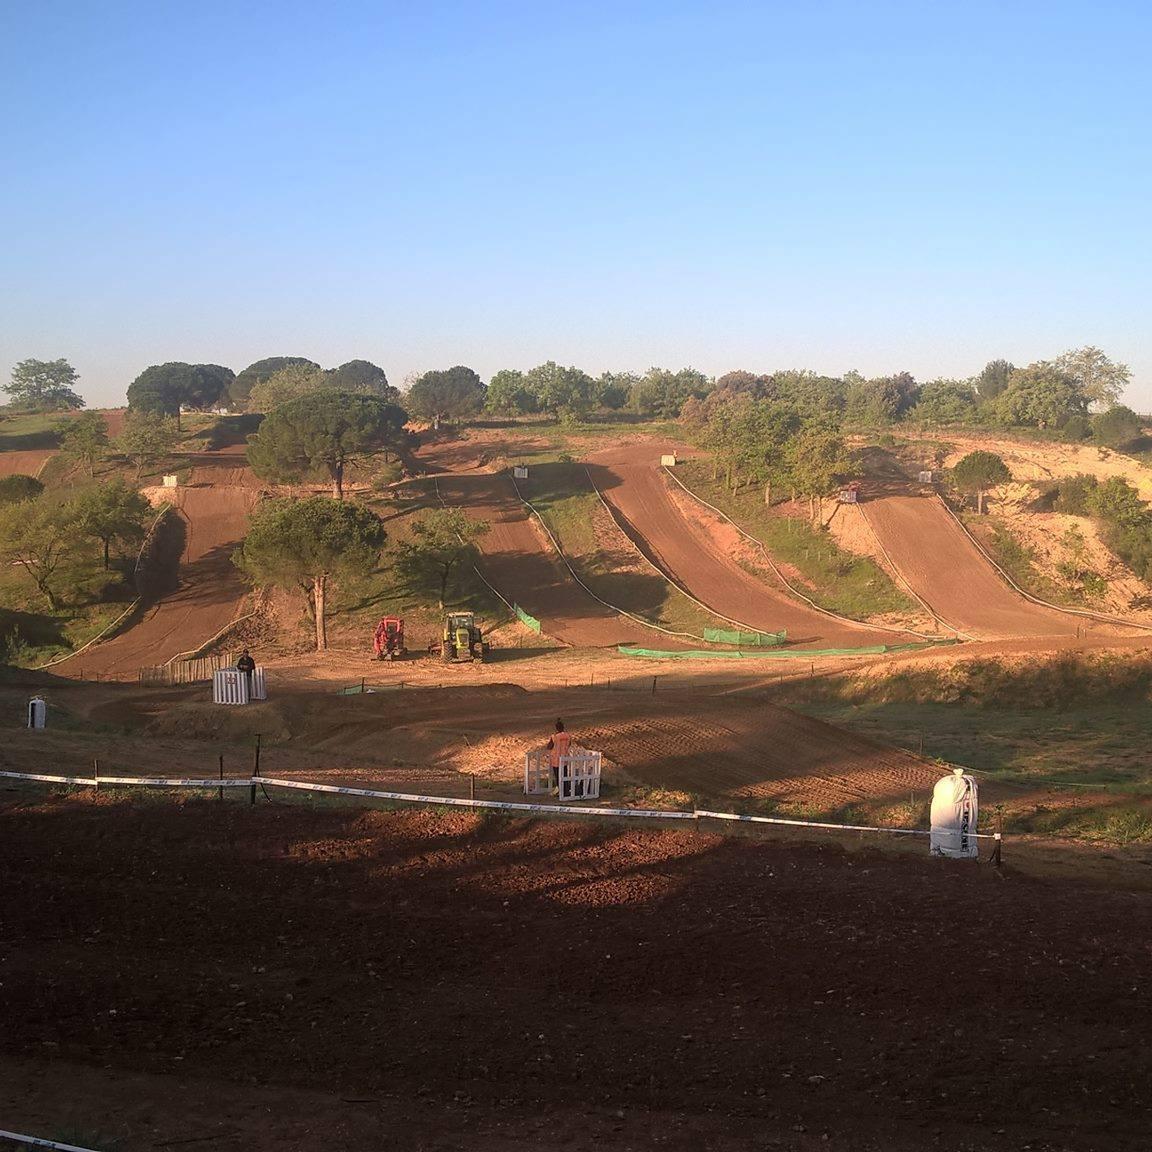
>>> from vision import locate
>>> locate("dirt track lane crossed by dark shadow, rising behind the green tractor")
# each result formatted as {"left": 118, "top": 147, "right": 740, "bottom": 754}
{"left": 438, "top": 472, "right": 684, "bottom": 649}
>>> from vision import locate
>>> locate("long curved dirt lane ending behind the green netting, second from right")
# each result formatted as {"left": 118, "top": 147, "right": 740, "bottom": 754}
{"left": 589, "top": 447, "right": 914, "bottom": 649}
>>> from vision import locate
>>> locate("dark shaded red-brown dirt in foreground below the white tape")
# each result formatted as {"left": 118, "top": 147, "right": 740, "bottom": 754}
{"left": 0, "top": 796, "right": 1152, "bottom": 1152}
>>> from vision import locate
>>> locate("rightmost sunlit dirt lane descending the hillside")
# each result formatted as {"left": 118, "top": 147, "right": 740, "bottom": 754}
{"left": 859, "top": 495, "right": 1116, "bottom": 639}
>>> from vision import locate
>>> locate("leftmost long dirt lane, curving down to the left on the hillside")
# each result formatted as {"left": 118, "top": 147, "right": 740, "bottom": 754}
{"left": 56, "top": 449, "right": 260, "bottom": 680}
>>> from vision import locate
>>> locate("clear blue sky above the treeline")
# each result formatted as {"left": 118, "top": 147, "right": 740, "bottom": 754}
{"left": 0, "top": 0, "right": 1152, "bottom": 410}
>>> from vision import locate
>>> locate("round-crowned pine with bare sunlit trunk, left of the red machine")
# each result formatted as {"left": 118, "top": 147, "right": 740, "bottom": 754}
{"left": 233, "top": 497, "right": 387, "bottom": 652}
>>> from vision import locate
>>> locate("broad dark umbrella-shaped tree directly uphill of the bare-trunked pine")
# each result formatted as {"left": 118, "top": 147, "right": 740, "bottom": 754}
{"left": 248, "top": 392, "right": 408, "bottom": 500}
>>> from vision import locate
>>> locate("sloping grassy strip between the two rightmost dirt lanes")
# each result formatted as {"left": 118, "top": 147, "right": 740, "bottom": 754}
{"left": 676, "top": 460, "right": 919, "bottom": 620}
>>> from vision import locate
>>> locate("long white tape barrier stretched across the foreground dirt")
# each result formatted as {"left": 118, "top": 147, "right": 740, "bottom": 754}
{"left": 0, "top": 772, "right": 1000, "bottom": 840}
